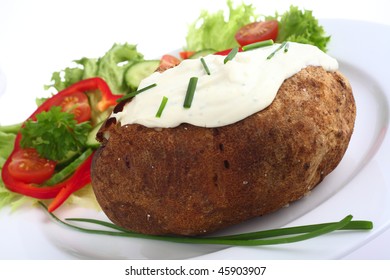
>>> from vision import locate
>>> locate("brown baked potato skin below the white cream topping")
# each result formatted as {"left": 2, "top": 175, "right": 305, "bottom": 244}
{"left": 92, "top": 66, "right": 356, "bottom": 235}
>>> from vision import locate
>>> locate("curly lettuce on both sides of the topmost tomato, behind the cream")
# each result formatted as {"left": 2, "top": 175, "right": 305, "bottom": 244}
{"left": 184, "top": 0, "right": 330, "bottom": 51}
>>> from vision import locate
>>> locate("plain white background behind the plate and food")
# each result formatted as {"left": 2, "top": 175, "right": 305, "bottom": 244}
{"left": 0, "top": 0, "right": 390, "bottom": 259}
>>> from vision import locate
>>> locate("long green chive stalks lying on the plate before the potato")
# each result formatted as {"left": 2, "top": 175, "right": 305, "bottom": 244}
{"left": 39, "top": 202, "right": 373, "bottom": 246}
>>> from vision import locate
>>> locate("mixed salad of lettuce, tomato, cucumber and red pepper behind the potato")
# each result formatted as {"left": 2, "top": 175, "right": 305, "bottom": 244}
{"left": 0, "top": 0, "right": 370, "bottom": 245}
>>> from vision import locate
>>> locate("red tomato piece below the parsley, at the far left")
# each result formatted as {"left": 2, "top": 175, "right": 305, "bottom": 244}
{"left": 8, "top": 148, "right": 56, "bottom": 184}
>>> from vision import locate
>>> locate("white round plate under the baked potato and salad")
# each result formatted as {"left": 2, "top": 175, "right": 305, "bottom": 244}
{"left": 0, "top": 20, "right": 390, "bottom": 259}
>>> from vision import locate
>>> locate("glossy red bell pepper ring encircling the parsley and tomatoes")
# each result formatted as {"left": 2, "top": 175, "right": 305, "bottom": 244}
{"left": 1, "top": 77, "right": 122, "bottom": 211}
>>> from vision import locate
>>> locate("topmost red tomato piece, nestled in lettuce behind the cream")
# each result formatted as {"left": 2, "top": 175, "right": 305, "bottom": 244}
{"left": 235, "top": 20, "right": 279, "bottom": 46}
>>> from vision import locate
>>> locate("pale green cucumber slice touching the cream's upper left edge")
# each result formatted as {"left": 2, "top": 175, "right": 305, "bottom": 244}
{"left": 125, "top": 60, "right": 160, "bottom": 89}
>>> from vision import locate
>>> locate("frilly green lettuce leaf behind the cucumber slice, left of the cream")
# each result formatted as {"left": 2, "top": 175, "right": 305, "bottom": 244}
{"left": 45, "top": 43, "right": 143, "bottom": 94}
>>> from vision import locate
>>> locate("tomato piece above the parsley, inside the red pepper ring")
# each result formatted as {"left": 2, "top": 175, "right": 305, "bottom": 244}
{"left": 52, "top": 92, "right": 91, "bottom": 123}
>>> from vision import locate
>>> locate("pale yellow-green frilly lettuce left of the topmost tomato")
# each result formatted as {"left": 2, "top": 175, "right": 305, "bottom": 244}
{"left": 185, "top": 0, "right": 257, "bottom": 51}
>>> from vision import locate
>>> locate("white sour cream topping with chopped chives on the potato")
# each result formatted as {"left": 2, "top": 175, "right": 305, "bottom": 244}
{"left": 111, "top": 42, "right": 338, "bottom": 128}
